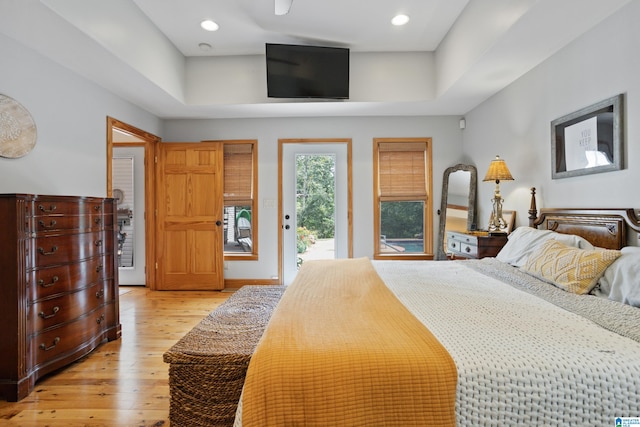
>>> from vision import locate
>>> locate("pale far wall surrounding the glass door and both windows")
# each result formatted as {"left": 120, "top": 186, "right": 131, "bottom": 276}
{"left": 163, "top": 116, "right": 462, "bottom": 279}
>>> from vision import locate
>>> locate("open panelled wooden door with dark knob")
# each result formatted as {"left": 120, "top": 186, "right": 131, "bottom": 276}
{"left": 156, "top": 142, "right": 224, "bottom": 290}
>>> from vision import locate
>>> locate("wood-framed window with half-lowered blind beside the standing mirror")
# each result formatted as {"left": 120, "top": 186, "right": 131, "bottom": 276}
{"left": 373, "top": 138, "right": 433, "bottom": 259}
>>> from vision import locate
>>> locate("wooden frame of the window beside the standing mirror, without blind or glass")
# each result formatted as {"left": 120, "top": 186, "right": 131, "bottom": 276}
{"left": 373, "top": 138, "right": 433, "bottom": 260}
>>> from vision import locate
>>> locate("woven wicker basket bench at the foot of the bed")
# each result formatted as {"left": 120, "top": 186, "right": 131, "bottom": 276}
{"left": 163, "top": 286, "right": 285, "bottom": 427}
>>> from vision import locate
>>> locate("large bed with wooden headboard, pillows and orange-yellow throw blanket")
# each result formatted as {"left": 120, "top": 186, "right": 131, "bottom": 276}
{"left": 172, "top": 191, "right": 640, "bottom": 427}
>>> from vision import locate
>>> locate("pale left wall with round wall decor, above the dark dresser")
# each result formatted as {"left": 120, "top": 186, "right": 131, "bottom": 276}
{"left": 0, "top": 35, "right": 161, "bottom": 197}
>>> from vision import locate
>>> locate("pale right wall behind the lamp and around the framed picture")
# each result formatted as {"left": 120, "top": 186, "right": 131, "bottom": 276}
{"left": 463, "top": 2, "right": 640, "bottom": 232}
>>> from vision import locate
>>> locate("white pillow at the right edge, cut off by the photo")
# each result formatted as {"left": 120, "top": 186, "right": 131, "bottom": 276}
{"left": 597, "top": 246, "right": 640, "bottom": 307}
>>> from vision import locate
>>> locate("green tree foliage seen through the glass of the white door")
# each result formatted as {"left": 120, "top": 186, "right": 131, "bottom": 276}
{"left": 296, "top": 154, "right": 335, "bottom": 239}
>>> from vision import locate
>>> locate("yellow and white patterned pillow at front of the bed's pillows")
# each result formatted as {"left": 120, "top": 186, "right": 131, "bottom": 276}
{"left": 523, "top": 239, "right": 620, "bottom": 295}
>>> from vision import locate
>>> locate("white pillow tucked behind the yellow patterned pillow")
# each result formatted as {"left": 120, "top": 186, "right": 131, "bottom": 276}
{"left": 496, "top": 227, "right": 594, "bottom": 267}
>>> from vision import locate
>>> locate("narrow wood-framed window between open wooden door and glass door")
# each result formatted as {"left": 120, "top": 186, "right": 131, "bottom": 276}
{"left": 223, "top": 140, "right": 258, "bottom": 260}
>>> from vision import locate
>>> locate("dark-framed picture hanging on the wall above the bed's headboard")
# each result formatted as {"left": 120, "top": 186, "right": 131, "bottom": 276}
{"left": 551, "top": 94, "right": 624, "bottom": 179}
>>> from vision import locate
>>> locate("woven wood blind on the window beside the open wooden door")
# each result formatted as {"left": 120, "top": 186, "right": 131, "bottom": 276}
{"left": 224, "top": 144, "right": 253, "bottom": 205}
